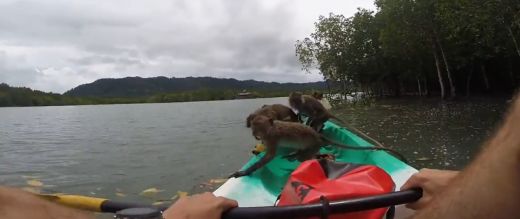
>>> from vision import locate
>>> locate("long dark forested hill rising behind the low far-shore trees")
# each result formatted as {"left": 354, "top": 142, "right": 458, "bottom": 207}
{"left": 65, "top": 77, "right": 326, "bottom": 97}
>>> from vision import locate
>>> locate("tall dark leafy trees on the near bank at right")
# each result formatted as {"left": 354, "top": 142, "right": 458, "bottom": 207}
{"left": 296, "top": 0, "right": 520, "bottom": 98}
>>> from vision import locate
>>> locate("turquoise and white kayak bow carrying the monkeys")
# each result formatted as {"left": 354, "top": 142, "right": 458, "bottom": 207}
{"left": 213, "top": 121, "right": 417, "bottom": 218}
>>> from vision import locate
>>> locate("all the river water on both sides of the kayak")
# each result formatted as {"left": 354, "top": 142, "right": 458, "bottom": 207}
{"left": 0, "top": 98, "right": 505, "bottom": 202}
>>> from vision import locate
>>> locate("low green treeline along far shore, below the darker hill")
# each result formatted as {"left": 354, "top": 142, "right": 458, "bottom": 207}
{"left": 0, "top": 84, "right": 306, "bottom": 107}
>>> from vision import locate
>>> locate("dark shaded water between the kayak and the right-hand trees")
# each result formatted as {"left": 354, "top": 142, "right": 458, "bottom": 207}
{"left": 334, "top": 99, "right": 506, "bottom": 169}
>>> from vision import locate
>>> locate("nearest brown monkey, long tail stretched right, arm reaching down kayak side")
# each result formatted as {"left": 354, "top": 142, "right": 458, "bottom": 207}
{"left": 229, "top": 115, "right": 408, "bottom": 178}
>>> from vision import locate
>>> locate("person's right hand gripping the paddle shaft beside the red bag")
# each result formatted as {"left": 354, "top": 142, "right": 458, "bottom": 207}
{"left": 401, "top": 169, "right": 459, "bottom": 210}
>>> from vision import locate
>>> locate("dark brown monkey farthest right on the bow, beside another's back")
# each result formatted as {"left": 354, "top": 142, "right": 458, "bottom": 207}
{"left": 289, "top": 92, "right": 345, "bottom": 131}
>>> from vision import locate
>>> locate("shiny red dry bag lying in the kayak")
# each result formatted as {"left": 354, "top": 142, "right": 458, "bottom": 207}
{"left": 277, "top": 160, "right": 395, "bottom": 219}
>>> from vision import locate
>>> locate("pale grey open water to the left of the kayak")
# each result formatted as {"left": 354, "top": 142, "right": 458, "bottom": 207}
{"left": 0, "top": 98, "right": 286, "bottom": 204}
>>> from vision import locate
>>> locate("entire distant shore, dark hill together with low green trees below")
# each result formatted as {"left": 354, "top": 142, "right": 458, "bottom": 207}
{"left": 0, "top": 77, "right": 326, "bottom": 107}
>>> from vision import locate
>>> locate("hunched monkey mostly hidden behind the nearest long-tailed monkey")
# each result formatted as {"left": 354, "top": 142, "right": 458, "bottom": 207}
{"left": 246, "top": 104, "right": 299, "bottom": 128}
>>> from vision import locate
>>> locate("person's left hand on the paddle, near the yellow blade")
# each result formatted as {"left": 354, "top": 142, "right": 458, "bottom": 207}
{"left": 163, "top": 192, "right": 238, "bottom": 219}
